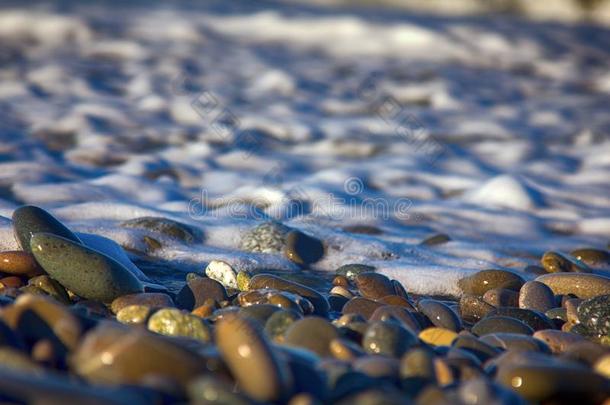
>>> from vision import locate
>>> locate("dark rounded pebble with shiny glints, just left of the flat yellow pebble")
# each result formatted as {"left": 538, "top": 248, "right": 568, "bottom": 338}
{"left": 362, "top": 321, "right": 418, "bottom": 357}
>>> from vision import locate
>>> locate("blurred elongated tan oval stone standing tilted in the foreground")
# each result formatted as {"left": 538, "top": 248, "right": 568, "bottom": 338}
{"left": 214, "top": 316, "right": 292, "bottom": 402}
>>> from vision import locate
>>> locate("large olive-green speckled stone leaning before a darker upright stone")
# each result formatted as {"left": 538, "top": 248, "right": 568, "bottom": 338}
{"left": 30, "top": 233, "right": 143, "bottom": 303}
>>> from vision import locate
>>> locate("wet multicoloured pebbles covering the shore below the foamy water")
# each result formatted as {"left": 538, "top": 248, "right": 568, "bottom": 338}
{"left": 0, "top": 206, "right": 610, "bottom": 405}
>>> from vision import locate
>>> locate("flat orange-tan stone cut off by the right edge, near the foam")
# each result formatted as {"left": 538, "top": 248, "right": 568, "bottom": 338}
{"left": 536, "top": 273, "right": 610, "bottom": 299}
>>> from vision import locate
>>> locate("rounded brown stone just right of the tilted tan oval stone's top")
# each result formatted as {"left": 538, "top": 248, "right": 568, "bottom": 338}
{"left": 284, "top": 316, "right": 339, "bottom": 357}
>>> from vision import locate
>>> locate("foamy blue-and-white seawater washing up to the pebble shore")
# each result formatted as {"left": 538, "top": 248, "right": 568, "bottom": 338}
{"left": 0, "top": 2, "right": 610, "bottom": 295}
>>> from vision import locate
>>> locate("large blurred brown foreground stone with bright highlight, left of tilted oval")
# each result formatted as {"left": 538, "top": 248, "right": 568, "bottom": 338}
{"left": 70, "top": 322, "right": 207, "bottom": 384}
